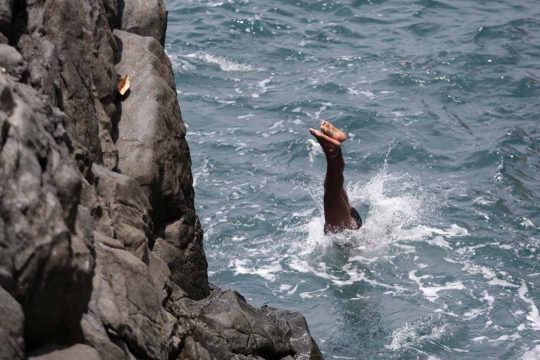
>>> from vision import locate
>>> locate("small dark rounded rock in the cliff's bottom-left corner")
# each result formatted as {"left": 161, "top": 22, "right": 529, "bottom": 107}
{"left": 0, "top": 286, "right": 24, "bottom": 360}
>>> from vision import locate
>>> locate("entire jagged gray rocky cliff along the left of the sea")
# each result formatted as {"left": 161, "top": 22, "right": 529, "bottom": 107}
{"left": 0, "top": 0, "right": 322, "bottom": 360}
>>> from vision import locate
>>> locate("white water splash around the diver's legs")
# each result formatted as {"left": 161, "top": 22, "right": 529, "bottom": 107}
{"left": 293, "top": 165, "right": 450, "bottom": 253}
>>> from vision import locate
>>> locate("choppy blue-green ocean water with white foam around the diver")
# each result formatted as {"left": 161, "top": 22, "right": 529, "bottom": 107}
{"left": 166, "top": 0, "right": 540, "bottom": 360}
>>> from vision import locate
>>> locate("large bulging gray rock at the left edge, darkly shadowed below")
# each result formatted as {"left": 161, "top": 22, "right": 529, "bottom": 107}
{"left": 0, "top": 74, "right": 94, "bottom": 349}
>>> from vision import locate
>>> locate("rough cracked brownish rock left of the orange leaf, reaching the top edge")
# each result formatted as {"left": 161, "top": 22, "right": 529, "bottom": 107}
{"left": 12, "top": 0, "right": 118, "bottom": 169}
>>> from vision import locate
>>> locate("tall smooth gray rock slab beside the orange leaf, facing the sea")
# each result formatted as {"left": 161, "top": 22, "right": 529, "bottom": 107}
{"left": 114, "top": 30, "right": 209, "bottom": 299}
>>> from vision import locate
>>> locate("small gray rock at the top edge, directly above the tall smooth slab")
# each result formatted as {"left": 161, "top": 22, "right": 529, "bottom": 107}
{"left": 116, "top": 0, "right": 167, "bottom": 46}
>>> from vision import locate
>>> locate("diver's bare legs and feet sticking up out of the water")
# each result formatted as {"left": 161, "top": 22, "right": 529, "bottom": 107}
{"left": 309, "top": 122, "right": 358, "bottom": 233}
